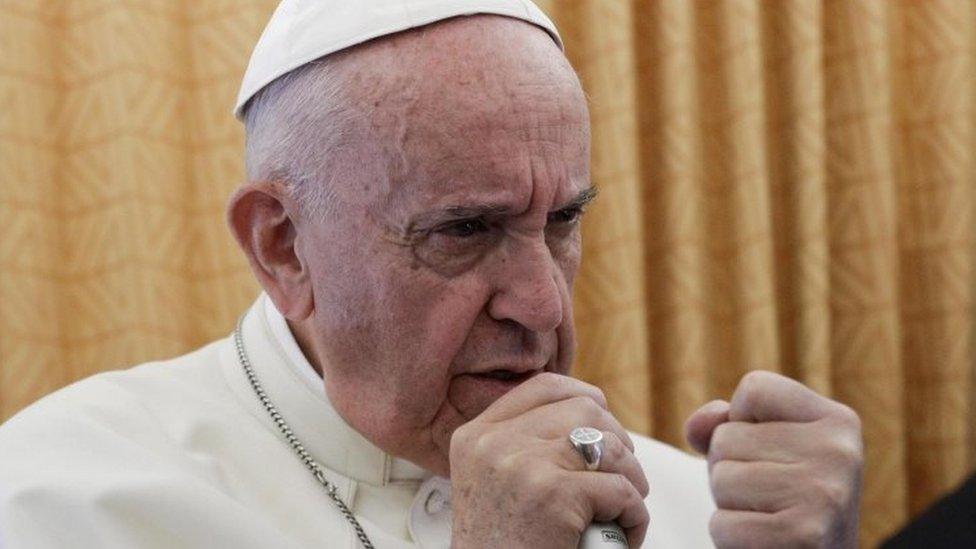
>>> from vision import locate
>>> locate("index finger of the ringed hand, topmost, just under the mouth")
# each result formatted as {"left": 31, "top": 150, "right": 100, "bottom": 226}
{"left": 480, "top": 372, "right": 607, "bottom": 421}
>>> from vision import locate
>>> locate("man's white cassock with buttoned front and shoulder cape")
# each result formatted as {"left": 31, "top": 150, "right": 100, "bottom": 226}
{"left": 0, "top": 294, "right": 714, "bottom": 549}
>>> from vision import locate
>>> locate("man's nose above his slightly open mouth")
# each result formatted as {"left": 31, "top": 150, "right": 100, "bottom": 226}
{"left": 488, "top": 242, "right": 568, "bottom": 333}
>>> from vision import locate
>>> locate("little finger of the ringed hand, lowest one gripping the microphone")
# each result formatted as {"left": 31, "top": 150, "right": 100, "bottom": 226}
{"left": 573, "top": 472, "right": 650, "bottom": 547}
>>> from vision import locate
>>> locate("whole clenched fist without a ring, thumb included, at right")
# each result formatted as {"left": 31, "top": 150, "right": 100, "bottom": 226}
{"left": 685, "top": 371, "right": 863, "bottom": 549}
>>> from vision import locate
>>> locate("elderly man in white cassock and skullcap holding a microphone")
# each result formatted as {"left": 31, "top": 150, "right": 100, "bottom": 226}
{"left": 0, "top": 0, "right": 861, "bottom": 548}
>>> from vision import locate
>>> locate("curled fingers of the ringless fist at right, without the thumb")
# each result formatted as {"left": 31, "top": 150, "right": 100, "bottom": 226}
{"left": 708, "top": 419, "right": 862, "bottom": 547}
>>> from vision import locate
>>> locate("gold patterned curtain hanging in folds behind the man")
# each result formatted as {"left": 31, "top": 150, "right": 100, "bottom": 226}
{"left": 0, "top": 0, "right": 976, "bottom": 546}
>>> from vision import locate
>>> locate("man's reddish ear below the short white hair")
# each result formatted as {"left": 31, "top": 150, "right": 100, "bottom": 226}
{"left": 227, "top": 181, "right": 314, "bottom": 321}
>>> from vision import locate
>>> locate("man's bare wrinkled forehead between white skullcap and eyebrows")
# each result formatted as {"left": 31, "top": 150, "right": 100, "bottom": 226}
{"left": 270, "top": 17, "right": 589, "bottom": 222}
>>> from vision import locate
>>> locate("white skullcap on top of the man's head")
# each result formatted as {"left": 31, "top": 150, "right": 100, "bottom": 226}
{"left": 234, "top": 0, "right": 563, "bottom": 119}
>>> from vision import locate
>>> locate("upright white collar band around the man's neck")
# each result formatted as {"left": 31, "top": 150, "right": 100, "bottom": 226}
{"left": 224, "top": 292, "right": 431, "bottom": 486}
